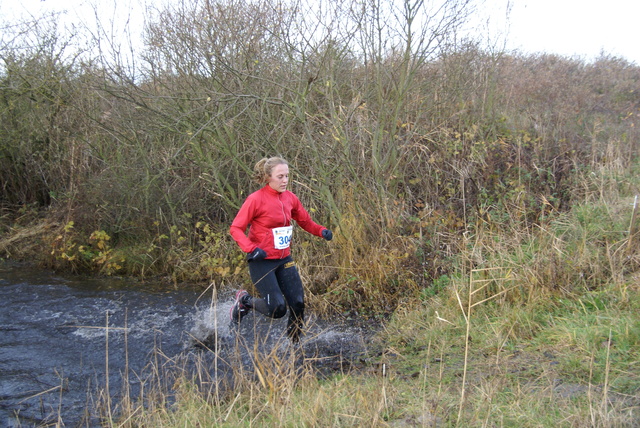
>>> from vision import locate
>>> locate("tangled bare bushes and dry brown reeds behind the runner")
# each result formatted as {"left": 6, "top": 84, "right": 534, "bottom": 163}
{"left": 0, "top": 0, "right": 640, "bottom": 312}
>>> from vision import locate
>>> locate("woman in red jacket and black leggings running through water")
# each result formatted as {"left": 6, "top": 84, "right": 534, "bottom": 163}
{"left": 229, "top": 157, "right": 333, "bottom": 342}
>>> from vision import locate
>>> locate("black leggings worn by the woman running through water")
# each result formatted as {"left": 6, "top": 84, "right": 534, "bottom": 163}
{"left": 249, "top": 256, "right": 304, "bottom": 340}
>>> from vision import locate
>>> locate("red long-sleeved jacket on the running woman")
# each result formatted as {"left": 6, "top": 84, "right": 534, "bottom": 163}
{"left": 229, "top": 185, "right": 326, "bottom": 259}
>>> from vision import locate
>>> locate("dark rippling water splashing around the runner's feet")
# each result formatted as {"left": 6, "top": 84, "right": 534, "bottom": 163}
{"left": 0, "top": 264, "right": 366, "bottom": 427}
